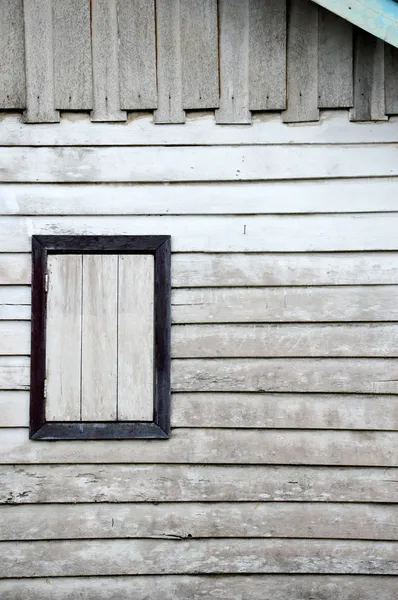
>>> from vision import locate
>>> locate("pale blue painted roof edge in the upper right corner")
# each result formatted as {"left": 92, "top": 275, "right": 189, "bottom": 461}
{"left": 313, "top": 0, "right": 398, "bottom": 48}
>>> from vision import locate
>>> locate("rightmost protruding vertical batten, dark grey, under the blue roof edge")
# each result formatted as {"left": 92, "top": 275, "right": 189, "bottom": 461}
{"left": 351, "top": 29, "right": 387, "bottom": 121}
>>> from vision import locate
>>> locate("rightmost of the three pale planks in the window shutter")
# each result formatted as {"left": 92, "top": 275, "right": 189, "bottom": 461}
{"left": 118, "top": 255, "right": 154, "bottom": 421}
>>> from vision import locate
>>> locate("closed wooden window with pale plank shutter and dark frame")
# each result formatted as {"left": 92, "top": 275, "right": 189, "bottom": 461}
{"left": 30, "top": 236, "right": 170, "bottom": 440}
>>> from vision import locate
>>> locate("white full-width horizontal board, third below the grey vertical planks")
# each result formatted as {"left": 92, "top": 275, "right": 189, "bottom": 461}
{"left": 0, "top": 178, "right": 398, "bottom": 216}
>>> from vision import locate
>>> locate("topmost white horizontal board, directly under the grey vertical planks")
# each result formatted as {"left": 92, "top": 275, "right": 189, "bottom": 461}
{"left": 0, "top": 111, "right": 398, "bottom": 146}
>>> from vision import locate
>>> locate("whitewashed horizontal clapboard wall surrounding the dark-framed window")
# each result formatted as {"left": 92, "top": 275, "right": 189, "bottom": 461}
{"left": 0, "top": 112, "right": 398, "bottom": 600}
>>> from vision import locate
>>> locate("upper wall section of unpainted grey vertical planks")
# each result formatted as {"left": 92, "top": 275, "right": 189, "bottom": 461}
{"left": 0, "top": 0, "right": 398, "bottom": 124}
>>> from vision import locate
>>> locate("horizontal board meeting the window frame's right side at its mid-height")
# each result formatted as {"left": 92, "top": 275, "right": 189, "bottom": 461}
{"left": 173, "top": 323, "right": 398, "bottom": 356}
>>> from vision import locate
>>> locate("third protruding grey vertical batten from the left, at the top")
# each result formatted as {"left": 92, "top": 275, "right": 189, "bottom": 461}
{"left": 154, "top": 0, "right": 185, "bottom": 123}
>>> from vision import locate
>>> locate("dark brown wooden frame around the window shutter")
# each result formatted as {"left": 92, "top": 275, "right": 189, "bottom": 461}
{"left": 29, "top": 235, "right": 171, "bottom": 441}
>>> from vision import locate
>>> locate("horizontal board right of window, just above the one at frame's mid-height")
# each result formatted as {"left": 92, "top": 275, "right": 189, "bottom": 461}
{"left": 172, "top": 286, "right": 398, "bottom": 323}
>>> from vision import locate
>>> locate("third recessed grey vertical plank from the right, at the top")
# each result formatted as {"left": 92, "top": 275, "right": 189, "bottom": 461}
{"left": 249, "top": 0, "right": 286, "bottom": 110}
